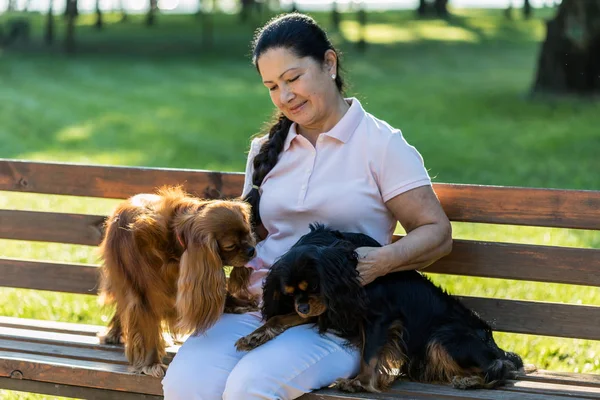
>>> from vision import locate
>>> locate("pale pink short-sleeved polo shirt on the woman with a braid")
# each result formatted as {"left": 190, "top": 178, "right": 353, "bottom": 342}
{"left": 243, "top": 98, "right": 431, "bottom": 294}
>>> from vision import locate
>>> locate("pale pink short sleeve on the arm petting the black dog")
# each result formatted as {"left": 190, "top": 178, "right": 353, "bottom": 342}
{"left": 378, "top": 130, "right": 431, "bottom": 202}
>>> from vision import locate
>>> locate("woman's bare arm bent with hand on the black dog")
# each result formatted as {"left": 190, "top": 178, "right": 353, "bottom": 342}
{"left": 356, "top": 186, "right": 452, "bottom": 285}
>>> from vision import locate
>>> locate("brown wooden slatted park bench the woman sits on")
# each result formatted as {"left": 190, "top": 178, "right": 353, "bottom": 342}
{"left": 0, "top": 160, "right": 600, "bottom": 400}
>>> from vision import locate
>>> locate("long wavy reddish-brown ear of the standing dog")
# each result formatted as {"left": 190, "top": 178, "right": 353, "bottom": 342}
{"left": 175, "top": 233, "right": 227, "bottom": 334}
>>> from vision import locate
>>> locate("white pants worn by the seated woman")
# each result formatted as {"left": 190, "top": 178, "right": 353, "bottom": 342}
{"left": 162, "top": 313, "right": 360, "bottom": 400}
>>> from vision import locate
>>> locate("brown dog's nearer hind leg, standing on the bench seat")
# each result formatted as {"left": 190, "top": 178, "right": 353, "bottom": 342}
{"left": 123, "top": 299, "right": 167, "bottom": 378}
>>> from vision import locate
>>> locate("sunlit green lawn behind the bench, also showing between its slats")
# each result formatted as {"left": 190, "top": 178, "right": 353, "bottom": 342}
{"left": 0, "top": 5, "right": 600, "bottom": 399}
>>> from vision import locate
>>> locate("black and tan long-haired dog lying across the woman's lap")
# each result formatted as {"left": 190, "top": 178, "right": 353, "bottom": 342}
{"left": 236, "top": 225, "right": 523, "bottom": 392}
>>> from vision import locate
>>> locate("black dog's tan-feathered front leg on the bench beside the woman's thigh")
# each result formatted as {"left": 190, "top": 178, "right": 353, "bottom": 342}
{"left": 335, "top": 320, "right": 406, "bottom": 393}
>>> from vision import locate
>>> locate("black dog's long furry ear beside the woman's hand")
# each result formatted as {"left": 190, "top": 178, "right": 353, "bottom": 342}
{"left": 318, "top": 241, "right": 367, "bottom": 332}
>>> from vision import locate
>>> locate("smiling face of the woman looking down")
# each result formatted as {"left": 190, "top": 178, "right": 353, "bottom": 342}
{"left": 257, "top": 48, "right": 339, "bottom": 127}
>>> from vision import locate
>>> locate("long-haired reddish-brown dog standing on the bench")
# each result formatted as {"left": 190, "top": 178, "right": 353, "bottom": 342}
{"left": 100, "top": 187, "right": 257, "bottom": 377}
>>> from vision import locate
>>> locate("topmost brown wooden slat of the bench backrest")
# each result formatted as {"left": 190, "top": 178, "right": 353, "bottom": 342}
{"left": 0, "top": 159, "right": 600, "bottom": 230}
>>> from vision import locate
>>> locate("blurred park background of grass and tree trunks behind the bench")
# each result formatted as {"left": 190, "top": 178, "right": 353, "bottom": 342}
{"left": 0, "top": 0, "right": 600, "bottom": 399}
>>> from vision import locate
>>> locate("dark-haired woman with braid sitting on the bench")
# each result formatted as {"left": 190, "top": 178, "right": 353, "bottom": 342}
{"left": 163, "top": 13, "right": 452, "bottom": 400}
